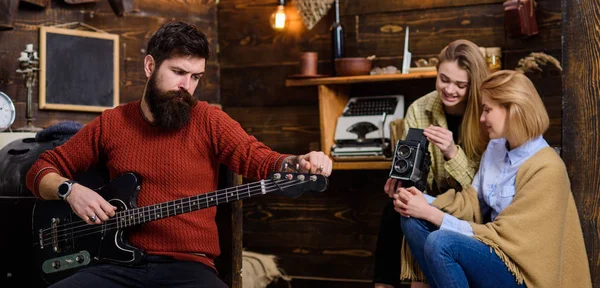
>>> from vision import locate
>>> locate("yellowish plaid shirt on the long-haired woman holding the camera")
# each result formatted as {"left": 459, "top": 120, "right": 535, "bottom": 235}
{"left": 402, "top": 91, "right": 479, "bottom": 196}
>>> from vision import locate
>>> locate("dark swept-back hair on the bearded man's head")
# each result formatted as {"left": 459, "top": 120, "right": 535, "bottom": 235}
{"left": 146, "top": 22, "right": 209, "bottom": 67}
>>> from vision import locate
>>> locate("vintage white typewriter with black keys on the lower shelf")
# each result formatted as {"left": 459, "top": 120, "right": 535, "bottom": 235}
{"left": 331, "top": 95, "right": 404, "bottom": 160}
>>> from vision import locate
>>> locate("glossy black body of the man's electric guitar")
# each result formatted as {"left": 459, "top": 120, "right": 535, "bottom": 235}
{"left": 32, "top": 173, "right": 144, "bottom": 283}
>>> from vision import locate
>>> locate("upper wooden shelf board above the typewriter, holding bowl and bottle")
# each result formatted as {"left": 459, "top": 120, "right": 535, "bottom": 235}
{"left": 285, "top": 71, "right": 437, "bottom": 87}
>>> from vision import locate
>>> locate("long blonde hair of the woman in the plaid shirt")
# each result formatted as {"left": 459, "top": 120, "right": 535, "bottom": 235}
{"left": 437, "top": 39, "right": 489, "bottom": 162}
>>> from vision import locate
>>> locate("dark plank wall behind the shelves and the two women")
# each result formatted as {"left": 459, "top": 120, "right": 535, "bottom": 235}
{"left": 218, "top": 0, "right": 562, "bottom": 287}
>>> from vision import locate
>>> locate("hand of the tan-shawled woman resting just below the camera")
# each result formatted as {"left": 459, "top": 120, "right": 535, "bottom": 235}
{"left": 393, "top": 187, "right": 444, "bottom": 227}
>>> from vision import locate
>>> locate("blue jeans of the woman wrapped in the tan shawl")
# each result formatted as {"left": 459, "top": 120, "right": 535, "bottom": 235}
{"left": 400, "top": 217, "right": 525, "bottom": 288}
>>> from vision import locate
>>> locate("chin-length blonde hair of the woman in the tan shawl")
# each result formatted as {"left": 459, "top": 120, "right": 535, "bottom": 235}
{"left": 481, "top": 70, "right": 550, "bottom": 147}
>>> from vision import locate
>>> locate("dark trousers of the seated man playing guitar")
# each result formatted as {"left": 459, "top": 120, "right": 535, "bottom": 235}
{"left": 51, "top": 255, "right": 227, "bottom": 288}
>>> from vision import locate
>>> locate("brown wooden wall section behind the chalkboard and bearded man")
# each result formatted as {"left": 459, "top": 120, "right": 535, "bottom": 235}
{"left": 0, "top": 0, "right": 220, "bottom": 128}
